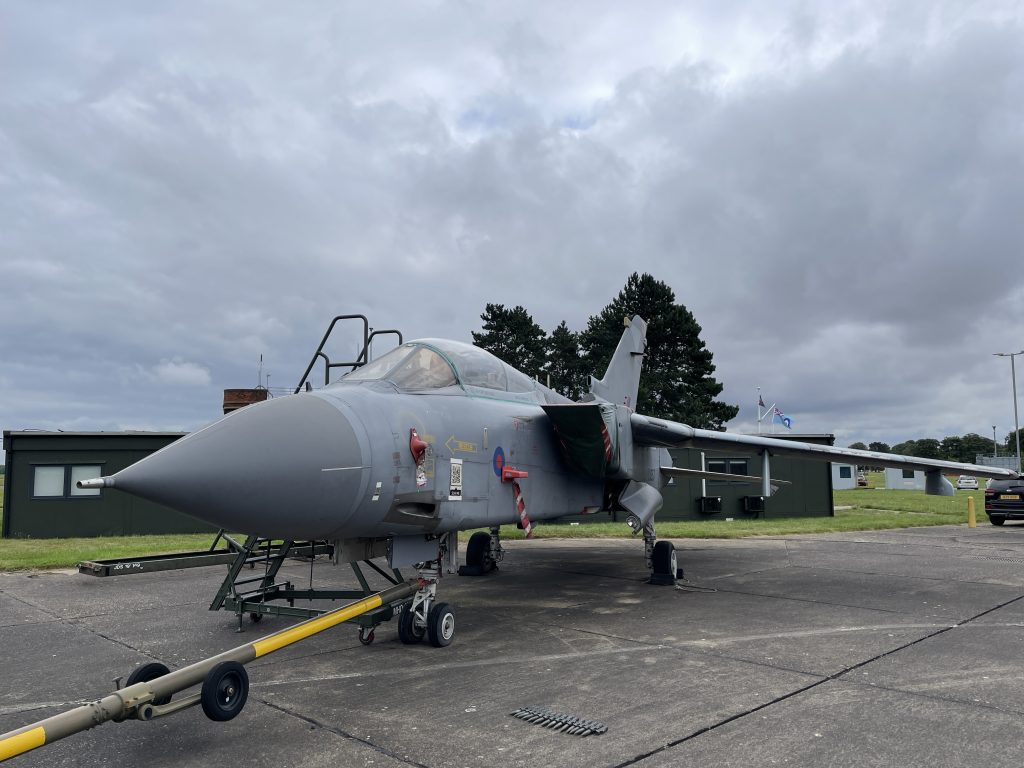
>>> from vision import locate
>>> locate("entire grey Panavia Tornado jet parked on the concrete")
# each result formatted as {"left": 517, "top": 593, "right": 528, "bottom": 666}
{"left": 79, "top": 316, "right": 1016, "bottom": 646}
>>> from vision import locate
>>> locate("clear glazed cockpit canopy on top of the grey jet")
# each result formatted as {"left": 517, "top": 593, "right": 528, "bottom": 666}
{"left": 343, "top": 339, "right": 537, "bottom": 393}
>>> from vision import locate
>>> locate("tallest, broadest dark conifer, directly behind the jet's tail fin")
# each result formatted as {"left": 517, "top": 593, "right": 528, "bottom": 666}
{"left": 580, "top": 272, "right": 739, "bottom": 429}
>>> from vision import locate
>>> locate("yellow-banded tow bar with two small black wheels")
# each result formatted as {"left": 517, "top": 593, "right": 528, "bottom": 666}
{"left": 0, "top": 582, "right": 420, "bottom": 762}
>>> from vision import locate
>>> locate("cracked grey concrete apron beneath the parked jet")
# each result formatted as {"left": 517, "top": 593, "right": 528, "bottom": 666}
{"left": 0, "top": 525, "right": 1024, "bottom": 768}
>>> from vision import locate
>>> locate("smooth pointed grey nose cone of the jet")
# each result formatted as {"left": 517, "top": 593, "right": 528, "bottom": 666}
{"left": 114, "top": 394, "right": 365, "bottom": 539}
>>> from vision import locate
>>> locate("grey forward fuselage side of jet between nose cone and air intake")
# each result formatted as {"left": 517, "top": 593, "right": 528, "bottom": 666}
{"left": 300, "top": 383, "right": 604, "bottom": 539}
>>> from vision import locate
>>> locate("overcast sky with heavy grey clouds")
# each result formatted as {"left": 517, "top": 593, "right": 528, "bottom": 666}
{"left": 0, "top": 0, "right": 1024, "bottom": 456}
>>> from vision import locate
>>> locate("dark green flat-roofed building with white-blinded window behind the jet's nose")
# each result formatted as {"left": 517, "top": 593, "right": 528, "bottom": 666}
{"left": 2, "top": 430, "right": 216, "bottom": 539}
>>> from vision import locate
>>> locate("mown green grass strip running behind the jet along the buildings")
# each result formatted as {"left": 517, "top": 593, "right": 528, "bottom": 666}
{"left": 0, "top": 473, "right": 988, "bottom": 570}
